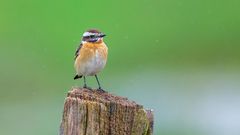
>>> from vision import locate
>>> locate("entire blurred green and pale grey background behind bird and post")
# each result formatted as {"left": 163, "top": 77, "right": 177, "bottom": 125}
{"left": 0, "top": 0, "right": 240, "bottom": 135}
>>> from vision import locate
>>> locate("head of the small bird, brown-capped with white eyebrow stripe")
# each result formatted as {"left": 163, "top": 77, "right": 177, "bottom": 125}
{"left": 82, "top": 29, "right": 106, "bottom": 43}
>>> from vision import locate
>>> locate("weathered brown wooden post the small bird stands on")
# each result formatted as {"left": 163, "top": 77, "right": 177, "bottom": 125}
{"left": 60, "top": 88, "right": 153, "bottom": 135}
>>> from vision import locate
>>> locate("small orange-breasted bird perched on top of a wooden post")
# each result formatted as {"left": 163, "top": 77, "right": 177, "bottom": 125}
{"left": 74, "top": 29, "right": 108, "bottom": 91}
